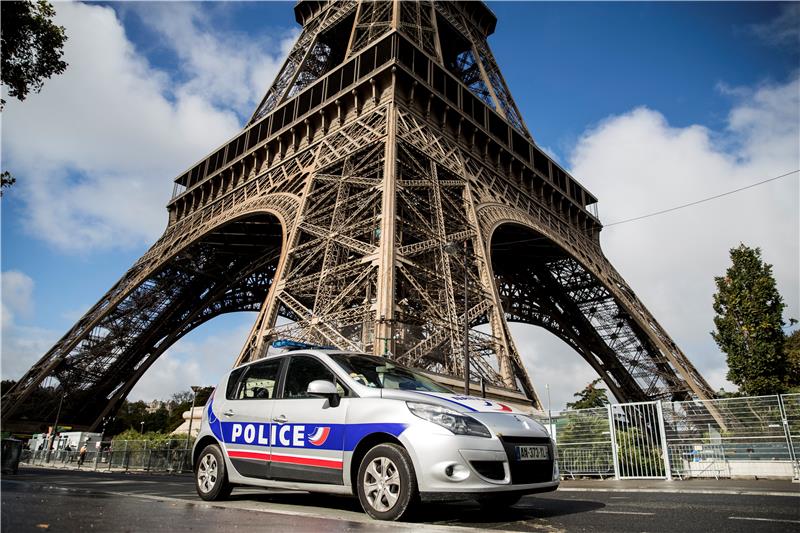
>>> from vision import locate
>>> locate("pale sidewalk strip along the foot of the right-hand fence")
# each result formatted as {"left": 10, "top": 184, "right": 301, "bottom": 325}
{"left": 559, "top": 479, "right": 800, "bottom": 497}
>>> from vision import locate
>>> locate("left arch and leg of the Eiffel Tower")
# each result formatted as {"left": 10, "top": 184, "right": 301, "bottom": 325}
{"left": 3, "top": 195, "right": 296, "bottom": 428}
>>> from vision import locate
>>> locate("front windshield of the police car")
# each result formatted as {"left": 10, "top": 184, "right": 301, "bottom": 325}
{"left": 331, "top": 353, "right": 453, "bottom": 393}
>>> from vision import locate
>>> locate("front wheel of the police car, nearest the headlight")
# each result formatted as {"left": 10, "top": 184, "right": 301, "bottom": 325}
{"left": 356, "top": 444, "right": 419, "bottom": 520}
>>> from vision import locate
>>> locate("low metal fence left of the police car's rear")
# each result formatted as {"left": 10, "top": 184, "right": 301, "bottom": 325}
{"left": 20, "top": 439, "right": 191, "bottom": 472}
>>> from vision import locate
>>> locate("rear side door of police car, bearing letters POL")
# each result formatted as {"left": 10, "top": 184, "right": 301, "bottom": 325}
{"left": 219, "top": 358, "right": 283, "bottom": 478}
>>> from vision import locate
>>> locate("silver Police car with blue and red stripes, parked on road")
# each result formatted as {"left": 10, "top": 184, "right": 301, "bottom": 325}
{"left": 192, "top": 350, "right": 559, "bottom": 520}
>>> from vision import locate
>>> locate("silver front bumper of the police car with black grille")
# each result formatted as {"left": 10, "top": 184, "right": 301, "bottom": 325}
{"left": 400, "top": 424, "right": 559, "bottom": 494}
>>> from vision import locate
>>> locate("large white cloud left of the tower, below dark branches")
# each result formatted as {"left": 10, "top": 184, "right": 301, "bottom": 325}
{"left": 3, "top": 3, "right": 294, "bottom": 252}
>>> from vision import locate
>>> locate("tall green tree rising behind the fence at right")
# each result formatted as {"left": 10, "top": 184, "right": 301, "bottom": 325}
{"left": 711, "top": 244, "right": 786, "bottom": 395}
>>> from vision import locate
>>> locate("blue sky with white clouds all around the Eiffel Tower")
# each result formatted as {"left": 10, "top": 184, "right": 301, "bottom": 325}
{"left": 2, "top": 2, "right": 800, "bottom": 406}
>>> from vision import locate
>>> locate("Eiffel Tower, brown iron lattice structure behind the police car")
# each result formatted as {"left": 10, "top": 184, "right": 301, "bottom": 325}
{"left": 2, "top": 0, "right": 713, "bottom": 428}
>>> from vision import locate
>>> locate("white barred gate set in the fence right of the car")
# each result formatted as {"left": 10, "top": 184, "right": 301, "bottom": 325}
{"left": 608, "top": 402, "right": 672, "bottom": 479}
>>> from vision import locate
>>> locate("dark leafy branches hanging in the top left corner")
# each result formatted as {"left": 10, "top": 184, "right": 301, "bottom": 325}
{"left": 0, "top": 0, "right": 67, "bottom": 104}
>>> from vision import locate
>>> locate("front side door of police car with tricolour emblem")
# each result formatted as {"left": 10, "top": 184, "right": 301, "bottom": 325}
{"left": 270, "top": 354, "right": 350, "bottom": 484}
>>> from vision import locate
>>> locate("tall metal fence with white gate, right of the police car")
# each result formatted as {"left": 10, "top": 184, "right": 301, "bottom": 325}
{"left": 537, "top": 394, "right": 800, "bottom": 480}
